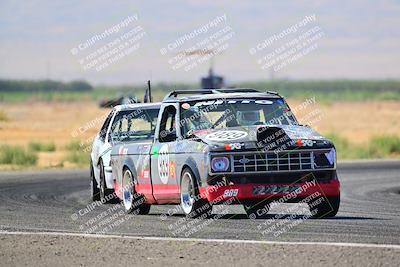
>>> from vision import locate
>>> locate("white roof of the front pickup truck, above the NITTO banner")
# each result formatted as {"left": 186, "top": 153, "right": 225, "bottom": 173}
{"left": 163, "top": 88, "right": 282, "bottom": 102}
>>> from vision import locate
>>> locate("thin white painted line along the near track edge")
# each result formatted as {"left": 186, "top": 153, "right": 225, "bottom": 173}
{"left": 0, "top": 231, "right": 400, "bottom": 249}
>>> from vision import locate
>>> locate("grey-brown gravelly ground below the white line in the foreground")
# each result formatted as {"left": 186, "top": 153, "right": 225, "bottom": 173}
{"left": 0, "top": 234, "right": 400, "bottom": 266}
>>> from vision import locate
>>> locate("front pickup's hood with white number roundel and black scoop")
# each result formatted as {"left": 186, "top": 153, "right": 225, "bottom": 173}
{"left": 193, "top": 125, "right": 330, "bottom": 149}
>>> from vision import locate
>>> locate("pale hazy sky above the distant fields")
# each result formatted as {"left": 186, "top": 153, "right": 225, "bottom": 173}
{"left": 0, "top": 0, "right": 400, "bottom": 84}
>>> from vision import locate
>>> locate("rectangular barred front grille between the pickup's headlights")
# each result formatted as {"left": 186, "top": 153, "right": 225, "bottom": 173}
{"left": 231, "top": 151, "right": 314, "bottom": 173}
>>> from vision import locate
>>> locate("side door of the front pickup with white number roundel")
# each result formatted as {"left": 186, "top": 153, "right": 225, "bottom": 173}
{"left": 151, "top": 104, "right": 181, "bottom": 203}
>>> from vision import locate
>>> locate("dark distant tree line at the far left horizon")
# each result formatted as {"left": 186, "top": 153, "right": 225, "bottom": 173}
{"left": 0, "top": 80, "right": 93, "bottom": 93}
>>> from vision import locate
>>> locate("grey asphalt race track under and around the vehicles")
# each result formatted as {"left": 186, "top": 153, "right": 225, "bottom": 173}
{"left": 0, "top": 161, "right": 400, "bottom": 265}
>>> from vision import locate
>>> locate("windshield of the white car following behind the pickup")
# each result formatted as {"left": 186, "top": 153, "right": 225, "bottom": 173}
{"left": 111, "top": 108, "right": 159, "bottom": 144}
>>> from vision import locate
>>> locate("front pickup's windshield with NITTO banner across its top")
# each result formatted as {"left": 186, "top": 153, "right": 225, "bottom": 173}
{"left": 181, "top": 98, "right": 297, "bottom": 133}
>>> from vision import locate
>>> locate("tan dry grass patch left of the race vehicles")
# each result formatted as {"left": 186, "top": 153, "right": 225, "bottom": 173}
{"left": 0, "top": 102, "right": 109, "bottom": 169}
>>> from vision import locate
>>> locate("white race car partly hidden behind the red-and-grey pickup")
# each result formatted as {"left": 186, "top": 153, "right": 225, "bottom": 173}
{"left": 90, "top": 103, "right": 161, "bottom": 203}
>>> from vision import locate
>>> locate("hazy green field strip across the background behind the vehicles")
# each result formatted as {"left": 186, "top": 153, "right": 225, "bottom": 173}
{"left": 0, "top": 80, "right": 400, "bottom": 102}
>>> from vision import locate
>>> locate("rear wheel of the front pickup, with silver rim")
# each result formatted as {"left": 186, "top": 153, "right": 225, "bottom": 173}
{"left": 121, "top": 168, "right": 151, "bottom": 215}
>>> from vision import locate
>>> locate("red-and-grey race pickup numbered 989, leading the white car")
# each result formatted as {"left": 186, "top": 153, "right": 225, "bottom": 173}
{"left": 111, "top": 89, "right": 340, "bottom": 218}
